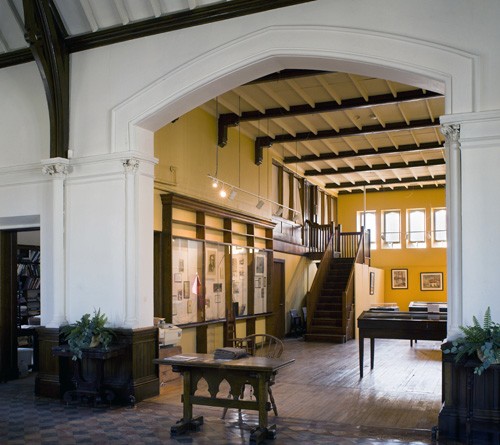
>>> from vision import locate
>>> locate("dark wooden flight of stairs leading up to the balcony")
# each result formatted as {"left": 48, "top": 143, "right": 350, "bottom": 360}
{"left": 306, "top": 258, "right": 354, "bottom": 343}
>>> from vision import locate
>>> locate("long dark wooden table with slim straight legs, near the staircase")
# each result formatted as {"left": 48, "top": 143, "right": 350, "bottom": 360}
{"left": 358, "top": 311, "right": 447, "bottom": 378}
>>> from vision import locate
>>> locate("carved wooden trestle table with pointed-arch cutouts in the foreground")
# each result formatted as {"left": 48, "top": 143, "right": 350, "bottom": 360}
{"left": 153, "top": 354, "right": 295, "bottom": 443}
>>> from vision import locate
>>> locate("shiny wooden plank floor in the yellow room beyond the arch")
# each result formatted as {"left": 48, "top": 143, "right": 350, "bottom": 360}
{"left": 150, "top": 339, "right": 441, "bottom": 430}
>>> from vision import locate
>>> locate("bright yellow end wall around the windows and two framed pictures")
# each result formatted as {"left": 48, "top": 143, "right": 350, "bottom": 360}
{"left": 338, "top": 189, "right": 446, "bottom": 310}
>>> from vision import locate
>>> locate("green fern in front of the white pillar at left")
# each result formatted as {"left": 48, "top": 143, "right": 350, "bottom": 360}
{"left": 61, "top": 309, "right": 115, "bottom": 360}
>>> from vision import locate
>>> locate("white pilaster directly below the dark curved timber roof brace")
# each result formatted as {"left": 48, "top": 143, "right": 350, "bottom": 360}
{"left": 42, "top": 158, "right": 69, "bottom": 328}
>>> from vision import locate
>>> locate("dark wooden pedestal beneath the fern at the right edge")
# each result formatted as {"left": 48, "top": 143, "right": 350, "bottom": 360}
{"left": 438, "top": 343, "right": 500, "bottom": 444}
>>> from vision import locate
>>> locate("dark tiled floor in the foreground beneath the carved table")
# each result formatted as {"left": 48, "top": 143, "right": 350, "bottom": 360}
{"left": 0, "top": 372, "right": 438, "bottom": 445}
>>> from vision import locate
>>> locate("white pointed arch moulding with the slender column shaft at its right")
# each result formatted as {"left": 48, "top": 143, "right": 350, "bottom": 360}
{"left": 111, "top": 25, "right": 478, "bottom": 329}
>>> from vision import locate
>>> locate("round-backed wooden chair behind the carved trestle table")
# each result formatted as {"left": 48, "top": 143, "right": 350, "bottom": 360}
{"left": 221, "top": 334, "right": 285, "bottom": 419}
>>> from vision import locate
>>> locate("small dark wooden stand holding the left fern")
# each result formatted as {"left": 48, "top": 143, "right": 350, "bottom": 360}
{"left": 52, "top": 345, "right": 126, "bottom": 404}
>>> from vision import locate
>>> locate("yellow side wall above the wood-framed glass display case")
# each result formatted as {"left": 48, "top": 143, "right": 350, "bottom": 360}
{"left": 154, "top": 108, "right": 272, "bottom": 230}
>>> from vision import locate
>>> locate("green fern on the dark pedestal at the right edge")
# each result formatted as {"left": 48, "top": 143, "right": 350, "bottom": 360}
{"left": 443, "top": 307, "right": 500, "bottom": 375}
